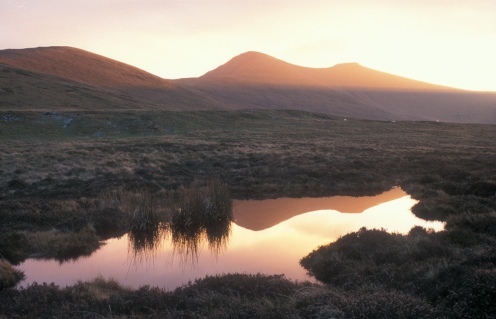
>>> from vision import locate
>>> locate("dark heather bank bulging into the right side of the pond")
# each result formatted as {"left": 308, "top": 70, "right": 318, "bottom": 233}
{"left": 300, "top": 226, "right": 496, "bottom": 318}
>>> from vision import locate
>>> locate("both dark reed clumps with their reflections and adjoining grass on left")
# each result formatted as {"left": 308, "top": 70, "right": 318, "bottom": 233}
{"left": 97, "top": 184, "right": 232, "bottom": 264}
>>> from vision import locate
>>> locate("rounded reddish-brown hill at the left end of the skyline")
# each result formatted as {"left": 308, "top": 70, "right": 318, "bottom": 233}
{"left": 0, "top": 47, "right": 220, "bottom": 109}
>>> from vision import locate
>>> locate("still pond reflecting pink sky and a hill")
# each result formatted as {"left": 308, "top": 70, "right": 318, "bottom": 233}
{"left": 19, "top": 188, "right": 444, "bottom": 290}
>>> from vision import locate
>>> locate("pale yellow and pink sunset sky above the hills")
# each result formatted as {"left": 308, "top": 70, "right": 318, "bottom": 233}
{"left": 0, "top": 0, "right": 496, "bottom": 91}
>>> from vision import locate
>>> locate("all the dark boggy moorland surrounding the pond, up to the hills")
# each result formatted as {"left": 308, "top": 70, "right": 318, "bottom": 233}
{"left": 0, "top": 111, "right": 496, "bottom": 318}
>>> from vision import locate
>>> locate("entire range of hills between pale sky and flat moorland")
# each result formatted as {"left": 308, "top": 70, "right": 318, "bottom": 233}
{"left": 0, "top": 47, "right": 496, "bottom": 124}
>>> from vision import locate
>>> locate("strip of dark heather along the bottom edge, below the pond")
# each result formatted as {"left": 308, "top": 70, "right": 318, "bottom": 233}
{"left": 0, "top": 274, "right": 443, "bottom": 319}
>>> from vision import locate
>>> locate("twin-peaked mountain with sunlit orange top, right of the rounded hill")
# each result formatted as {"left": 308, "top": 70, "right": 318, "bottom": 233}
{"left": 176, "top": 52, "right": 496, "bottom": 124}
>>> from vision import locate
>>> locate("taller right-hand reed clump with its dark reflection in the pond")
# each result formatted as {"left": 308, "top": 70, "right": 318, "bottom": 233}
{"left": 170, "top": 179, "right": 233, "bottom": 257}
